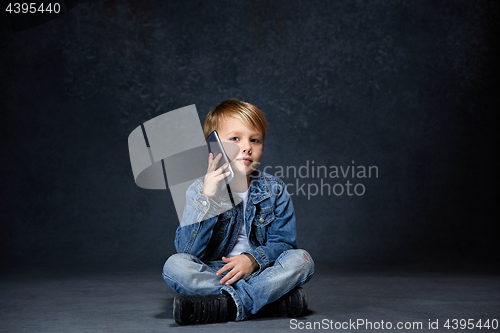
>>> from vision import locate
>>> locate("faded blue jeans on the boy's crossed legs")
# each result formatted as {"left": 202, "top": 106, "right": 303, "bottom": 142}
{"left": 163, "top": 249, "right": 314, "bottom": 320}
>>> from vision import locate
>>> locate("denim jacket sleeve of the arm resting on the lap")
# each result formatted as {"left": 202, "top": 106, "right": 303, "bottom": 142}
{"left": 245, "top": 183, "right": 297, "bottom": 276}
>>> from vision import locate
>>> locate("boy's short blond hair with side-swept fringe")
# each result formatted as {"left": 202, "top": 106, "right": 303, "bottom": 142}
{"left": 203, "top": 99, "right": 267, "bottom": 140}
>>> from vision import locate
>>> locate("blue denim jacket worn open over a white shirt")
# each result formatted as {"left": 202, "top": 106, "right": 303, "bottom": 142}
{"left": 175, "top": 170, "right": 297, "bottom": 276}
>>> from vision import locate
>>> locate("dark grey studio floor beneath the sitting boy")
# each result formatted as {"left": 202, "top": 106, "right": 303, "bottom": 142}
{"left": 0, "top": 264, "right": 500, "bottom": 333}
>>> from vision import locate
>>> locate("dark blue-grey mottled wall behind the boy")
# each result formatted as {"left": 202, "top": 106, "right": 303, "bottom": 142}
{"left": 0, "top": 0, "right": 500, "bottom": 267}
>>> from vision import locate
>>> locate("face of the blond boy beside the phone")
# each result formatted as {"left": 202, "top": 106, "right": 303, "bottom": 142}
{"left": 217, "top": 116, "right": 264, "bottom": 175}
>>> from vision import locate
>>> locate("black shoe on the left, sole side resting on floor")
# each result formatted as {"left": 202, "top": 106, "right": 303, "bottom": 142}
{"left": 174, "top": 294, "right": 235, "bottom": 325}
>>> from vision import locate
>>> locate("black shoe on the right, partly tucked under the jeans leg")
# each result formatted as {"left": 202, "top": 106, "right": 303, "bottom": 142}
{"left": 259, "top": 287, "right": 307, "bottom": 318}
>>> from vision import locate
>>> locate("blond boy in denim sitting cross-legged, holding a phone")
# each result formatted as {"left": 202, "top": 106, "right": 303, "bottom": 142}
{"left": 163, "top": 100, "right": 314, "bottom": 325}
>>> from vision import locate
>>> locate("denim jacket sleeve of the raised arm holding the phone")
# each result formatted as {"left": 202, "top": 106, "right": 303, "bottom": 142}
{"left": 174, "top": 180, "right": 225, "bottom": 257}
